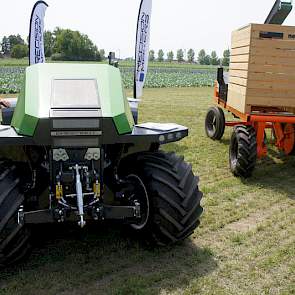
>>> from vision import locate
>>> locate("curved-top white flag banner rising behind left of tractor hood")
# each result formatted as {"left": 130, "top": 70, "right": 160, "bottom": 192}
{"left": 29, "top": 1, "right": 48, "bottom": 65}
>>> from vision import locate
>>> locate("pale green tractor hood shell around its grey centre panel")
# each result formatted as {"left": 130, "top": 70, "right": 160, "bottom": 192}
{"left": 12, "top": 63, "right": 134, "bottom": 136}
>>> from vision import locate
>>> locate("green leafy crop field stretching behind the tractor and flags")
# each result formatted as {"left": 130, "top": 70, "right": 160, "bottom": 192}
{"left": 0, "top": 59, "right": 216, "bottom": 94}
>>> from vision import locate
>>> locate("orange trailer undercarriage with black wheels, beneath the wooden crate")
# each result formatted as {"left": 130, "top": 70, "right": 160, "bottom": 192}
{"left": 205, "top": 68, "right": 295, "bottom": 178}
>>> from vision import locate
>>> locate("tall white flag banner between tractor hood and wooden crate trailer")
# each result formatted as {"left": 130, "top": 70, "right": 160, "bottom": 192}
{"left": 134, "top": 0, "right": 152, "bottom": 98}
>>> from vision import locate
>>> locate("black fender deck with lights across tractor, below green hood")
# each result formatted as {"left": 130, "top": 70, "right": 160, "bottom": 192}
{"left": 0, "top": 118, "right": 188, "bottom": 147}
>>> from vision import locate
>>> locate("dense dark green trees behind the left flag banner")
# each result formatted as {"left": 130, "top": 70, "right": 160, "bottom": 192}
{"left": 0, "top": 28, "right": 105, "bottom": 61}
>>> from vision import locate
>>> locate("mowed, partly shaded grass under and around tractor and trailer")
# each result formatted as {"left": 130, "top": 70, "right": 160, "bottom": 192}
{"left": 0, "top": 88, "right": 295, "bottom": 295}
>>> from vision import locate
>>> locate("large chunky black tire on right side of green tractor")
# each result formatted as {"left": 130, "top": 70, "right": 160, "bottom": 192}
{"left": 124, "top": 151, "right": 203, "bottom": 246}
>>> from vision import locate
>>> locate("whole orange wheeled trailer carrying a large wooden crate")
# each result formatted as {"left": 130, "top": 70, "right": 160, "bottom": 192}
{"left": 205, "top": 0, "right": 295, "bottom": 177}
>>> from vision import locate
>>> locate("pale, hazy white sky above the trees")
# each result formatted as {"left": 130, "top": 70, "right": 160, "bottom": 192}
{"left": 0, "top": 0, "right": 295, "bottom": 57}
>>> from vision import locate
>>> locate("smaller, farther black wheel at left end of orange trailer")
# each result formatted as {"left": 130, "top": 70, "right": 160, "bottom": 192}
{"left": 205, "top": 107, "right": 225, "bottom": 140}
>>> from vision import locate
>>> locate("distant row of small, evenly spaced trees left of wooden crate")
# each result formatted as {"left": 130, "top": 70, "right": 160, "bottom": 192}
{"left": 149, "top": 49, "right": 230, "bottom": 66}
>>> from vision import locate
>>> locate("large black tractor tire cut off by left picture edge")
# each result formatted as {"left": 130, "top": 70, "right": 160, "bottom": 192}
{"left": 0, "top": 161, "right": 30, "bottom": 268}
